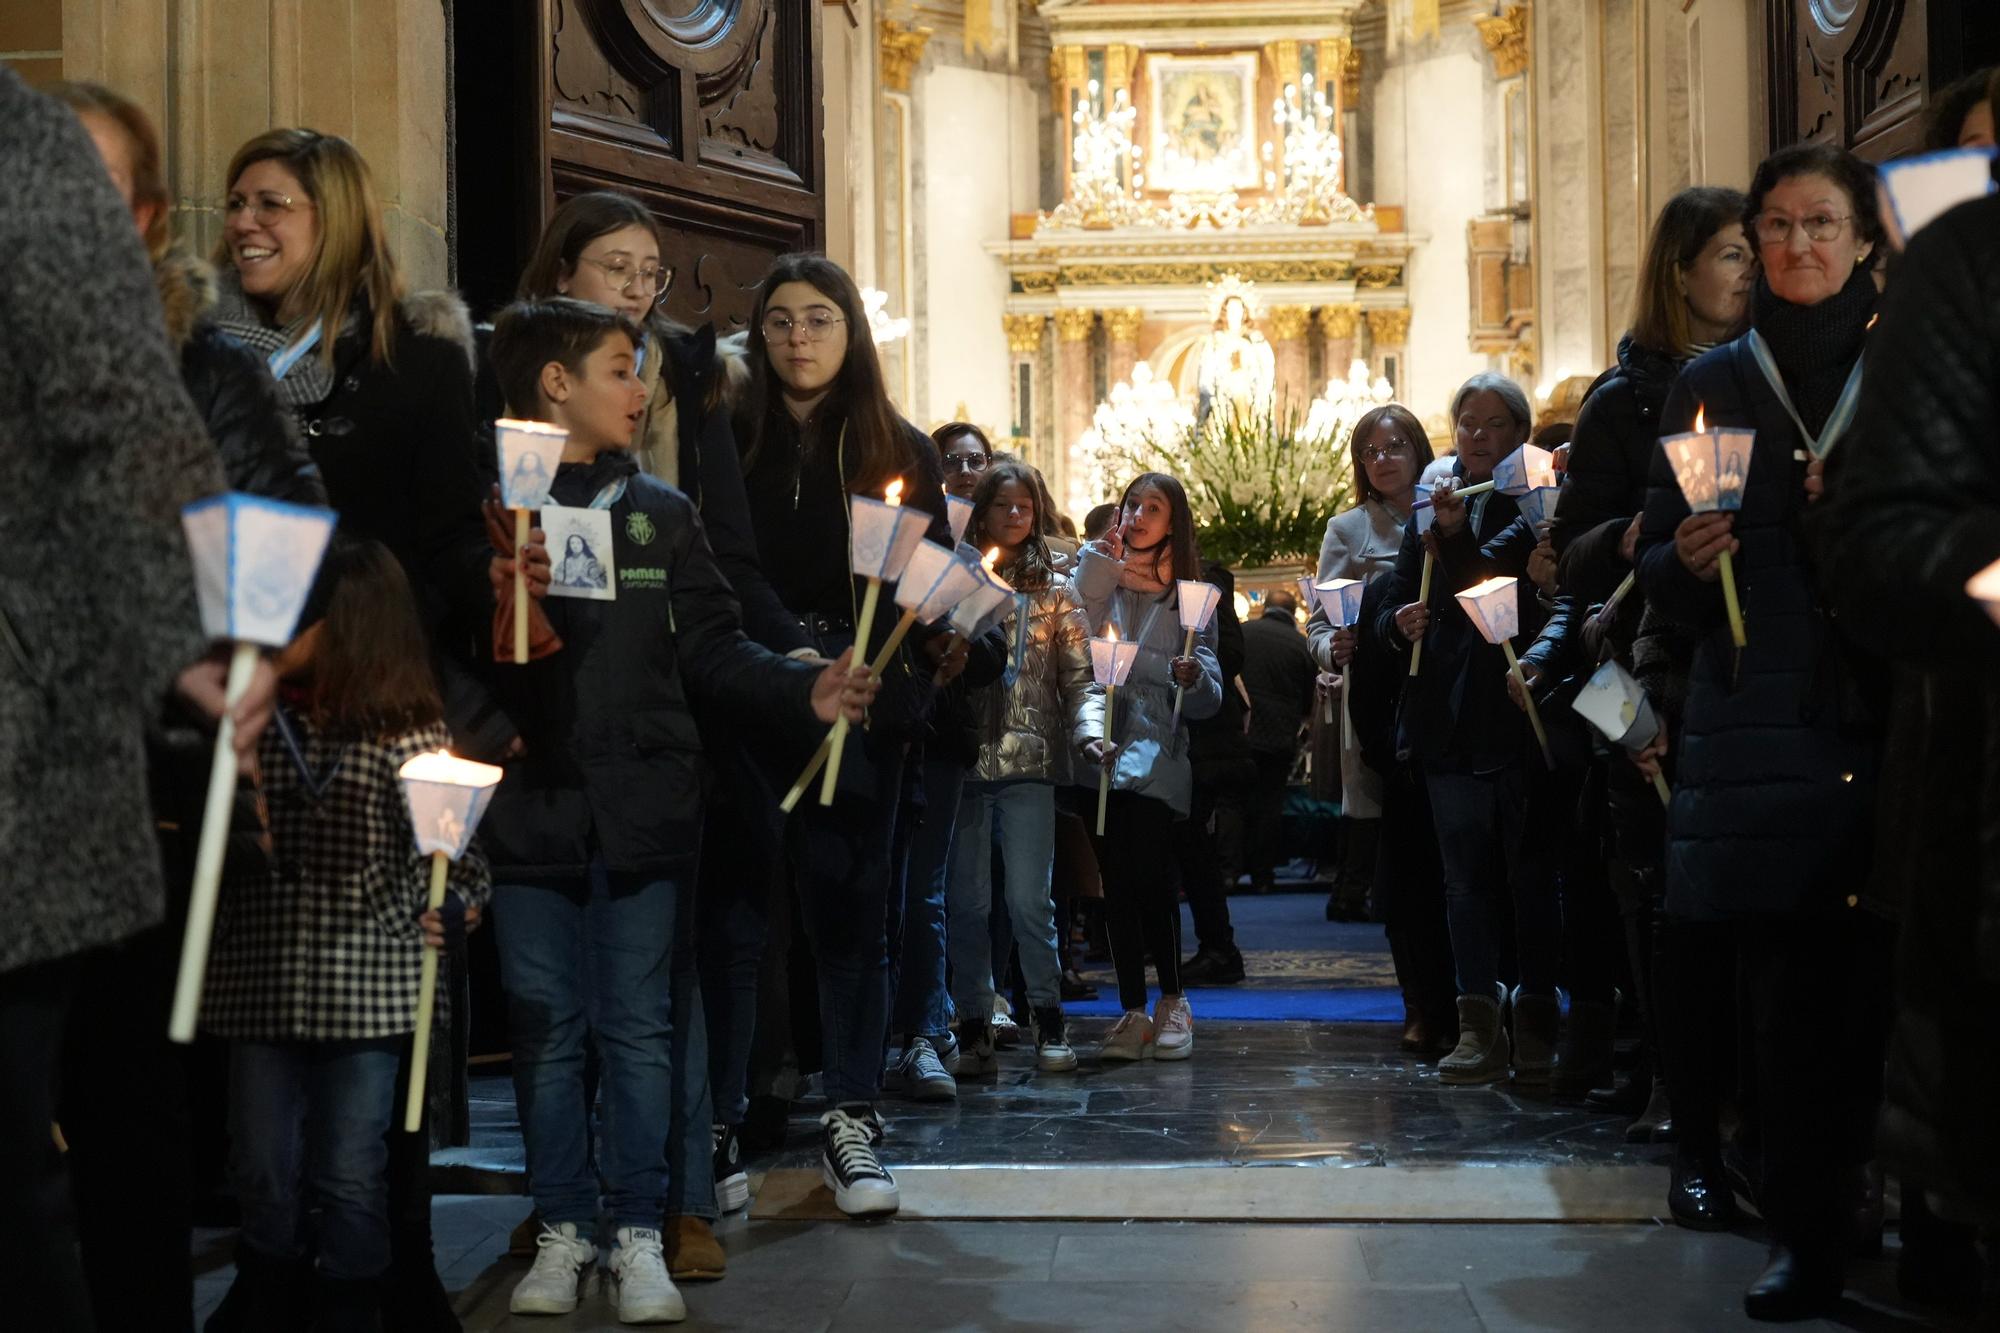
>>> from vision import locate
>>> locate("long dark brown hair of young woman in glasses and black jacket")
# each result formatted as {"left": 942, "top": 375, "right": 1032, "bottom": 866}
{"left": 744, "top": 254, "right": 912, "bottom": 494}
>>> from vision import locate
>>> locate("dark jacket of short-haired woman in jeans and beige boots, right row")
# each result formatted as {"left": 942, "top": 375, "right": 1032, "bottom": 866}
{"left": 1374, "top": 458, "right": 1546, "bottom": 773}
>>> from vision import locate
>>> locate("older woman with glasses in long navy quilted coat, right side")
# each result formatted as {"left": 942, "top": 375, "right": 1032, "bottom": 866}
{"left": 1638, "top": 144, "right": 1888, "bottom": 1319}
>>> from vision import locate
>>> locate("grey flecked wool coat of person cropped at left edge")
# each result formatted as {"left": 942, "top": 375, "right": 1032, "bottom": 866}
{"left": 0, "top": 68, "right": 224, "bottom": 973}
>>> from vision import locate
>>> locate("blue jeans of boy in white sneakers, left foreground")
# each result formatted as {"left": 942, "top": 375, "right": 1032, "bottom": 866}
{"left": 494, "top": 861, "right": 684, "bottom": 1235}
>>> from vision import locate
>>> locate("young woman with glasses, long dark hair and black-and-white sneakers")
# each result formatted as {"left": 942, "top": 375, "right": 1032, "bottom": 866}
{"left": 736, "top": 254, "right": 962, "bottom": 1217}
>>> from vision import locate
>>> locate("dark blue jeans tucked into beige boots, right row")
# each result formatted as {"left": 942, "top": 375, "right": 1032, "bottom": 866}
{"left": 1424, "top": 767, "right": 1562, "bottom": 995}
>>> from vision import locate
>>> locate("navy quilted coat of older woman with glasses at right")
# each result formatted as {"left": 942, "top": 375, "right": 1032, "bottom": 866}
{"left": 1640, "top": 298, "right": 1876, "bottom": 919}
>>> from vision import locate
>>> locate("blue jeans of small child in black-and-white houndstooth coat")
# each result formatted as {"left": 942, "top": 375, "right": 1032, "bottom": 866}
{"left": 230, "top": 1037, "right": 410, "bottom": 1281}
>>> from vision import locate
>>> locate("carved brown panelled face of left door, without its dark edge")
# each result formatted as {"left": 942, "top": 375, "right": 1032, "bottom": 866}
{"left": 536, "top": 0, "right": 824, "bottom": 332}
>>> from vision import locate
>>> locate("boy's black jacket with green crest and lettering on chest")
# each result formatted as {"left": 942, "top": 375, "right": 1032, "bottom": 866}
{"left": 480, "top": 454, "right": 822, "bottom": 883}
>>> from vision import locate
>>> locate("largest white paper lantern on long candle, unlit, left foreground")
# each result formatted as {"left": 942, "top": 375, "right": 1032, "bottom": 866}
{"left": 166, "top": 492, "right": 334, "bottom": 1043}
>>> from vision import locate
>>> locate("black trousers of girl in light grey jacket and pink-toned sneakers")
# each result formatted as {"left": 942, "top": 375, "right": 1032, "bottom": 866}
{"left": 1098, "top": 791, "right": 1180, "bottom": 1009}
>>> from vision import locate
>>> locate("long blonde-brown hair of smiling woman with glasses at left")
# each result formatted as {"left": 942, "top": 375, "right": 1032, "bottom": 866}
{"left": 216, "top": 130, "right": 404, "bottom": 366}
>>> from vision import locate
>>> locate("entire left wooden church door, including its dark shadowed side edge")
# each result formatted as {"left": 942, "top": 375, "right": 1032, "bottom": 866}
{"left": 454, "top": 0, "right": 826, "bottom": 334}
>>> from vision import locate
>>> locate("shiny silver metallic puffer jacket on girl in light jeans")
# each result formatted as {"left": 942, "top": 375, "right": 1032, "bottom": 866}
{"left": 966, "top": 574, "right": 1096, "bottom": 785}
